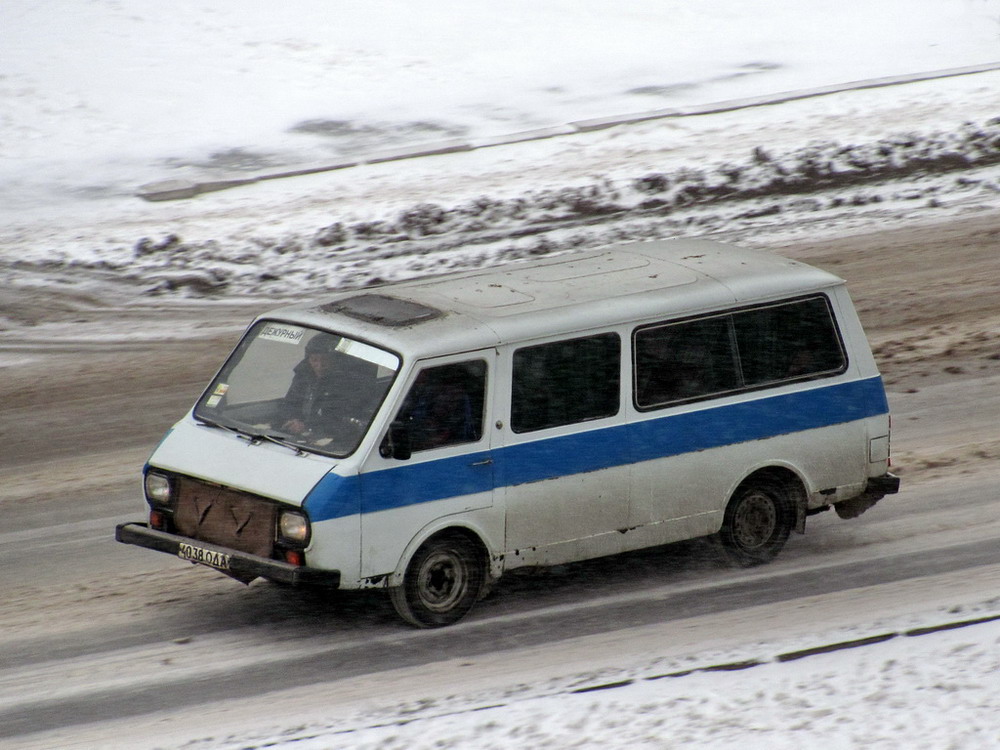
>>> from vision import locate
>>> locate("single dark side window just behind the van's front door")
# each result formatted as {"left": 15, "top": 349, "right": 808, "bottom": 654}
{"left": 510, "top": 333, "right": 621, "bottom": 432}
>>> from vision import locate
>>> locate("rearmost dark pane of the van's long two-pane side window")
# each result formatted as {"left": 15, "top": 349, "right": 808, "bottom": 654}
{"left": 733, "top": 297, "right": 847, "bottom": 387}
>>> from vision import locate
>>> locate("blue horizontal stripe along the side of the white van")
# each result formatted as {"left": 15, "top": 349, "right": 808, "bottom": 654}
{"left": 305, "top": 377, "right": 889, "bottom": 522}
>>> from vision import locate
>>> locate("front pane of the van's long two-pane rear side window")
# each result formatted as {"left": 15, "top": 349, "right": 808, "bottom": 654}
{"left": 635, "top": 315, "right": 740, "bottom": 408}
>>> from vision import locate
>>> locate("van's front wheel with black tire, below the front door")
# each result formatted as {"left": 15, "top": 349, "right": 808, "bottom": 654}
{"left": 389, "top": 534, "right": 485, "bottom": 628}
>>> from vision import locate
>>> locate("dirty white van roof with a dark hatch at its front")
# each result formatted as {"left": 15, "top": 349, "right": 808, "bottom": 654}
{"left": 261, "top": 240, "right": 843, "bottom": 357}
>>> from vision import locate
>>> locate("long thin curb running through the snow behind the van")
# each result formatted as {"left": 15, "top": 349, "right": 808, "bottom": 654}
{"left": 136, "top": 62, "right": 1000, "bottom": 201}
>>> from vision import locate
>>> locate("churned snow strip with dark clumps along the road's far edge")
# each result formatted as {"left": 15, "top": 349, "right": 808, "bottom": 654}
{"left": 41, "top": 117, "right": 1000, "bottom": 296}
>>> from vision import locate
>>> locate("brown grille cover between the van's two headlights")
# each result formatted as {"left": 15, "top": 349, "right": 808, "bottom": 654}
{"left": 174, "top": 478, "right": 278, "bottom": 557}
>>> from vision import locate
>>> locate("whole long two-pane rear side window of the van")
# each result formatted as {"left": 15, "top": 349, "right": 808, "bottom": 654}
{"left": 634, "top": 296, "right": 847, "bottom": 409}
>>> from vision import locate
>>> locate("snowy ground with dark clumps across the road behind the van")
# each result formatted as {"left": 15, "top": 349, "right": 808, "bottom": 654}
{"left": 0, "top": 0, "right": 1000, "bottom": 306}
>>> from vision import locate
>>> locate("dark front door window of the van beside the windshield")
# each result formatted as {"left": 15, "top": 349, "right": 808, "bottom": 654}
{"left": 396, "top": 360, "right": 486, "bottom": 452}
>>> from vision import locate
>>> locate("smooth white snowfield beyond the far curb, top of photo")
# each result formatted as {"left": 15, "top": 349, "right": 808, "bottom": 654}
{"left": 0, "top": 0, "right": 1000, "bottom": 208}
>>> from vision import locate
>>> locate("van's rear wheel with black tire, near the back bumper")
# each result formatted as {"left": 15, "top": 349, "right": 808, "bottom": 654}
{"left": 719, "top": 481, "right": 795, "bottom": 567}
